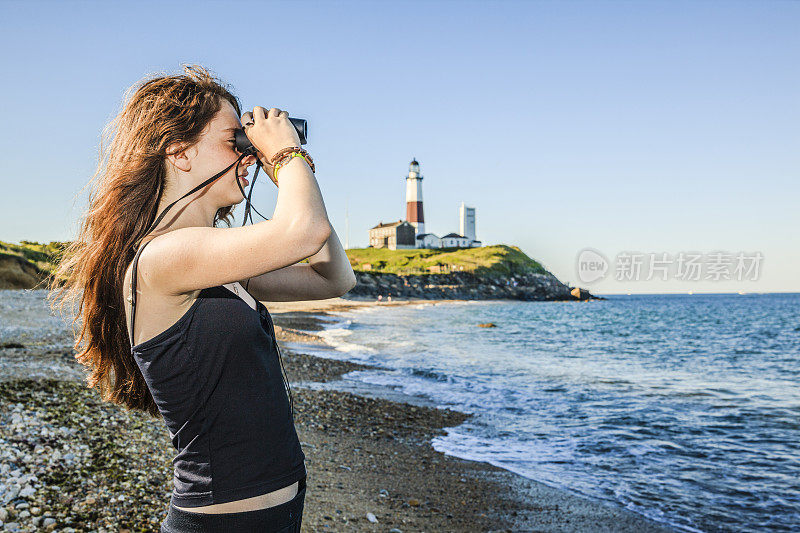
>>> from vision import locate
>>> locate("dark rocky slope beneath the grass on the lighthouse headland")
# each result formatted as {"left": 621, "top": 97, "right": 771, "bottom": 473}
{"left": 344, "top": 272, "right": 595, "bottom": 301}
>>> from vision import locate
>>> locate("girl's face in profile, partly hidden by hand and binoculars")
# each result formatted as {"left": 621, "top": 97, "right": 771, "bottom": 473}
{"left": 191, "top": 100, "right": 256, "bottom": 207}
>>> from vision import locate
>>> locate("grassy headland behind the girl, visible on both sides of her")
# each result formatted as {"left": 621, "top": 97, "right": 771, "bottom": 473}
{"left": 0, "top": 241, "right": 602, "bottom": 301}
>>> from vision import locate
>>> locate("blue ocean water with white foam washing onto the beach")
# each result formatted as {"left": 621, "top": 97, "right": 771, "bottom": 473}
{"left": 290, "top": 294, "right": 800, "bottom": 532}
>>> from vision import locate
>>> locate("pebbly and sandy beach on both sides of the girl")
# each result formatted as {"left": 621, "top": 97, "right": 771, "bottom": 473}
{"left": 0, "top": 298, "right": 672, "bottom": 533}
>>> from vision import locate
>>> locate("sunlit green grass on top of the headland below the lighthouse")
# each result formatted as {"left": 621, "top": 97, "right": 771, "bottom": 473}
{"left": 347, "top": 244, "right": 548, "bottom": 277}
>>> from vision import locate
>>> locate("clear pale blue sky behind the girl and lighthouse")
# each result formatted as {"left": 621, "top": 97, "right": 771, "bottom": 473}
{"left": 0, "top": 1, "right": 800, "bottom": 293}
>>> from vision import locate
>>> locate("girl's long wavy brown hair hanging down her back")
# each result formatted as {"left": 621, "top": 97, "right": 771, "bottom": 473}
{"left": 48, "top": 65, "right": 241, "bottom": 417}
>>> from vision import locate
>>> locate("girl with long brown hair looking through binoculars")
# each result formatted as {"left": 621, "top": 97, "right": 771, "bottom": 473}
{"left": 50, "top": 66, "right": 355, "bottom": 533}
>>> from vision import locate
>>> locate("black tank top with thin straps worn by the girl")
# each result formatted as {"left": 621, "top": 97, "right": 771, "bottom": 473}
{"left": 129, "top": 241, "right": 306, "bottom": 507}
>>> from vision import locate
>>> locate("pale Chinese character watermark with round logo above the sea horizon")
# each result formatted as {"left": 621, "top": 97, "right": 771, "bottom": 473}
{"left": 576, "top": 248, "right": 764, "bottom": 283}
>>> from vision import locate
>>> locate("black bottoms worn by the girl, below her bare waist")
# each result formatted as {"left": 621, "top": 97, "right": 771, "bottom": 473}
{"left": 160, "top": 476, "right": 306, "bottom": 533}
